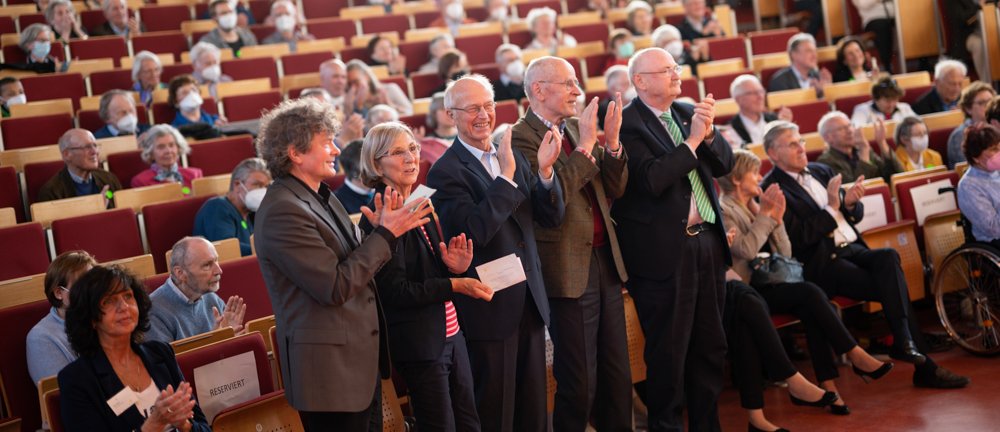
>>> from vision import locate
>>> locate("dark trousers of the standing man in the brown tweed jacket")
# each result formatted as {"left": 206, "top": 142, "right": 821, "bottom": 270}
{"left": 549, "top": 247, "right": 632, "bottom": 432}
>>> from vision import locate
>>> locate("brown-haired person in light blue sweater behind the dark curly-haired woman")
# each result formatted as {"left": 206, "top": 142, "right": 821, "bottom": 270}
{"left": 26, "top": 250, "right": 97, "bottom": 383}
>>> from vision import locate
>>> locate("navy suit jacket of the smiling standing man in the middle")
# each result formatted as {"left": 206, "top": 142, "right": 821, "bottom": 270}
{"left": 427, "top": 139, "right": 566, "bottom": 340}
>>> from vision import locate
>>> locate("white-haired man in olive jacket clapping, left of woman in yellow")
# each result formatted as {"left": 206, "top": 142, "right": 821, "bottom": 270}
{"left": 816, "top": 111, "right": 903, "bottom": 183}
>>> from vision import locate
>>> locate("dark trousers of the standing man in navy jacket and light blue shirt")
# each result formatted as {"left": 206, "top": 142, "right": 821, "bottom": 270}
{"left": 467, "top": 296, "right": 548, "bottom": 432}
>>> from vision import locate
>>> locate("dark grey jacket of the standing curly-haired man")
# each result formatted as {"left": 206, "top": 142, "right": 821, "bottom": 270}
{"left": 254, "top": 175, "right": 392, "bottom": 412}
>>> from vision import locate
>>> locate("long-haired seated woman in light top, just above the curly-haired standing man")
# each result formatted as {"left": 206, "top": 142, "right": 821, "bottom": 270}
{"left": 344, "top": 59, "right": 413, "bottom": 117}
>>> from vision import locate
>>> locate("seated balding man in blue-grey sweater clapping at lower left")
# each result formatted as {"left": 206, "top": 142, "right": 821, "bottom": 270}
{"left": 146, "top": 237, "right": 246, "bottom": 343}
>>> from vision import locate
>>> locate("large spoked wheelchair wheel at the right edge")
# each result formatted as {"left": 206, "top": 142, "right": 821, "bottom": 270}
{"left": 934, "top": 244, "right": 1000, "bottom": 356}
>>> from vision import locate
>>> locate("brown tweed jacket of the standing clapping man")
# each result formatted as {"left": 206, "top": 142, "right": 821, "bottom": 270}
{"left": 511, "top": 109, "right": 628, "bottom": 298}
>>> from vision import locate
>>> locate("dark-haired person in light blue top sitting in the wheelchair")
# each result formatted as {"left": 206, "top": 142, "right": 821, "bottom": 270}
{"left": 958, "top": 124, "right": 1000, "bottom": 248}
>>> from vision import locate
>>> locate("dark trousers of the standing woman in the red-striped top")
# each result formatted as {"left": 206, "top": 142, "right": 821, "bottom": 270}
{"left": 396, "top": 332, "right": 479, "bottom": 432}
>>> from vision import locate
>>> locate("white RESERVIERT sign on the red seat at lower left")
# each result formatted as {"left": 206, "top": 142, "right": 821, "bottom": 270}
{"left": 194, "top": 351, "right": 260, "bottom": 424}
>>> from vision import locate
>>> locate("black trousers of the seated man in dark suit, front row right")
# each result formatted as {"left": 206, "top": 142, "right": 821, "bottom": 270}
{"left": 757, "top": 282, "right": 858, "bottom": 381}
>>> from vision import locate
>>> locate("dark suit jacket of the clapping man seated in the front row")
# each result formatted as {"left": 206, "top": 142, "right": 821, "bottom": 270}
{"left": 761, "top": 162, "right": 865, "bottom": 280}
